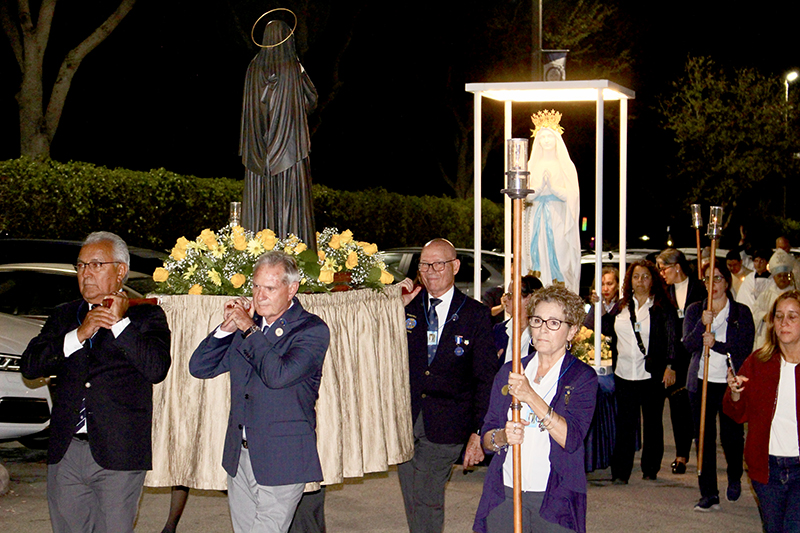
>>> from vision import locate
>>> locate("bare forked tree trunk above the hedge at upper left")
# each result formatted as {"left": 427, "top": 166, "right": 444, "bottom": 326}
{"left": 0, "top": 0, "right": 136, "bottom": 157}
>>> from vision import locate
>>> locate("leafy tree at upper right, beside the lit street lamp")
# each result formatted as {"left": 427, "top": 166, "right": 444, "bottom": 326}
{"left": 659, "top": 57, "right": 798, "bottom": 225}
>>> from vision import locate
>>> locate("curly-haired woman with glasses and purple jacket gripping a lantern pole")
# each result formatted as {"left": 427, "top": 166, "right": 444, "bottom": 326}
{"left": 473, "top": 285, "right": 597, "bottom": 533}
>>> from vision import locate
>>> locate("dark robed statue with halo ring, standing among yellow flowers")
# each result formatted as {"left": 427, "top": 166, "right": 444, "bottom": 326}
{"left": 239, "top": 20, "right": 317, "bottom": 250}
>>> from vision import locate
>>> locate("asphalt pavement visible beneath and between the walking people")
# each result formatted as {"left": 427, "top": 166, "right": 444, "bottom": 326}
{"left": 0, "top": 406, "right": 761, "bottom": 533}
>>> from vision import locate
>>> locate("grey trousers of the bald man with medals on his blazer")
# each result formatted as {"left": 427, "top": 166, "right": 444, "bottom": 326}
{"left": 397, "top": 413, "right": 464, "bottom": 533}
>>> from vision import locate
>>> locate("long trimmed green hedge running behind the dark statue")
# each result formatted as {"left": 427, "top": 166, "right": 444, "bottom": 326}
{"left": 0, "top": 158, "right": 503, "bottom": 250}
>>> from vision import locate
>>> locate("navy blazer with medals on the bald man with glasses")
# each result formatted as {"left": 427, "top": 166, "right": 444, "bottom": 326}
{"left": 406, "top": 288, "right": 502, "bottom": 444}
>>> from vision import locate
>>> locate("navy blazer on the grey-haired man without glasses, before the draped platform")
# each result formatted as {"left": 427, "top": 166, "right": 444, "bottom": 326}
{"left": 189, "top": 298, "right": 330, "bottom": 486}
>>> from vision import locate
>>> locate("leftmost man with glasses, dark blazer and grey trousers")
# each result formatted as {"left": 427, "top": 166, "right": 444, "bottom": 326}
{"left": 21, "top": 232, "right": 171, "bottom": 533}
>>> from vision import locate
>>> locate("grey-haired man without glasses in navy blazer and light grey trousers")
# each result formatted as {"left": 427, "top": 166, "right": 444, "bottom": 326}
{"left": 189, "top": 252, "right": 330, "bottom": 533}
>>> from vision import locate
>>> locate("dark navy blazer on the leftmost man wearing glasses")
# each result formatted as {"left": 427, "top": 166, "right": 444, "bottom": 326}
{"left": 20, "top": 300, "right": 171, "bottom": 470}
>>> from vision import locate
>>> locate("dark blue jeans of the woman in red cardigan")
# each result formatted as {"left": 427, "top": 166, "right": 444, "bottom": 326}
{"left": 753, "top": 455, "right": 800, "bottom": 533}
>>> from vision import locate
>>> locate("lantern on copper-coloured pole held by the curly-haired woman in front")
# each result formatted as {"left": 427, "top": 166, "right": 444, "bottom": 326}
{"left": 500, "top": 139, "right": 533, "bottom": 533}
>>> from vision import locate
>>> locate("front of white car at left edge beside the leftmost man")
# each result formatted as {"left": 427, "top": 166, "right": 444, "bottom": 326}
{"left": 0, "top": 313, "right": 53, "bottom": 448}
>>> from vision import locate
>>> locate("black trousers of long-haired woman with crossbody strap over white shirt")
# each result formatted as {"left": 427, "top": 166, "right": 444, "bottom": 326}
{"left": 611, "top": 376, "right": 664, "bottom": 481}
